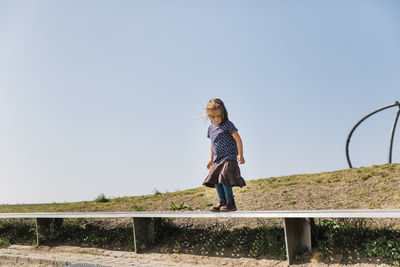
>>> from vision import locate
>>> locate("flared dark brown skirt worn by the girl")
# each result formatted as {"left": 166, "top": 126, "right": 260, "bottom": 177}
{"left": 203, "top": 160, "right": 246, "bottom": 188}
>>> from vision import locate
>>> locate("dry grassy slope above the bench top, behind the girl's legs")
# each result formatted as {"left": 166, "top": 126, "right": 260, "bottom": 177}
{"left": 0, "top": 164, "right": 400, "bottom": 213}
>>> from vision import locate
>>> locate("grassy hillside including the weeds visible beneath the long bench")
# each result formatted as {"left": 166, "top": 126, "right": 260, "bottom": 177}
{"left": 0, "top": 164, "right": 400, "bottom": 266}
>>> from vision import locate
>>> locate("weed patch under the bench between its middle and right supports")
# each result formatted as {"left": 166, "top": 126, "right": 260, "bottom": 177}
{"left": 155, "top": 220, "right": 285, "bottom": 259}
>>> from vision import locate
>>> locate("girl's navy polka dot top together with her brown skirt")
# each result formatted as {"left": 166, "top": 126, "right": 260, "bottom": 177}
{"left": 203, "top": 120, "right": 246, "bottom": 187}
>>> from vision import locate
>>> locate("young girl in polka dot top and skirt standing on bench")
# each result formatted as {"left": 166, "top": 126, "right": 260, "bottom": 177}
{"left": 203, "top": 98, "right": 246, "bottom": 211}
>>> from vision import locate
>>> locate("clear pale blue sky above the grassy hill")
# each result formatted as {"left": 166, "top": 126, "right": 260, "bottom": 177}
{"left": 0, "top": 0, "right": 400, "bottom": 203}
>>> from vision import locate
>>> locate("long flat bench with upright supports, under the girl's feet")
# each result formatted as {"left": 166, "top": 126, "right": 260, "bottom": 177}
{"left": 0, "top": 209, "right": 400, "bottom": 264}
